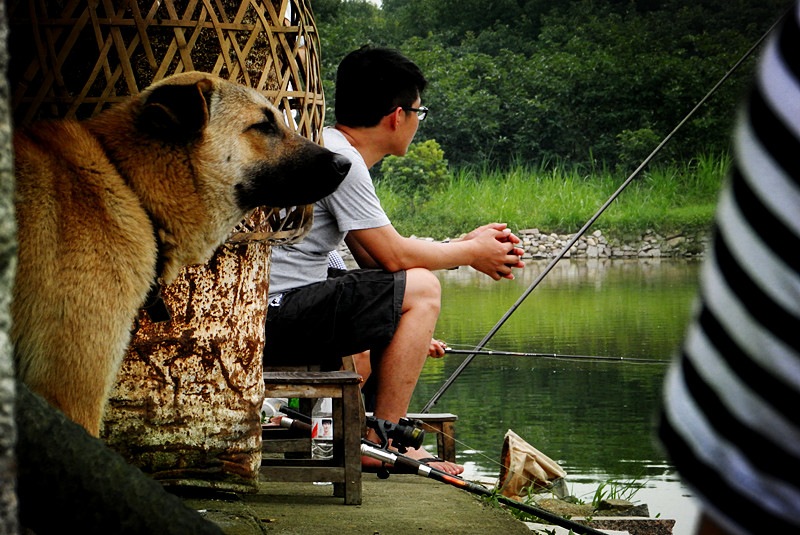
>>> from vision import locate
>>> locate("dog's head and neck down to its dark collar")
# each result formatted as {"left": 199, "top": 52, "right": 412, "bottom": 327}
{"left": 89, "top": 72, "right": 350, "bottom": 281}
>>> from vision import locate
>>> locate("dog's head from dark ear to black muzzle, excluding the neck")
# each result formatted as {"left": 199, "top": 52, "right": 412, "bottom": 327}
{"left": 137, "top": 73, "right": 350, "bottom": 210}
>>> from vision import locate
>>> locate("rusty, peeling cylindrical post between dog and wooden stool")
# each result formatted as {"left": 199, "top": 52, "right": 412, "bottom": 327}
{"left": 103, "top": 243, "right": 269, "bottom": 491}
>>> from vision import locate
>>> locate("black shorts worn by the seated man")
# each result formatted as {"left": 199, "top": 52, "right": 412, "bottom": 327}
{"left": 264, "top": 269, "right": 406, "bottom": 370}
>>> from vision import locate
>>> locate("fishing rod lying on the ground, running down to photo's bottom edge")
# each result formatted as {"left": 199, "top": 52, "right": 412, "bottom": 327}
{"left": 361, "top": 440, "right": 606, "bottom": 535}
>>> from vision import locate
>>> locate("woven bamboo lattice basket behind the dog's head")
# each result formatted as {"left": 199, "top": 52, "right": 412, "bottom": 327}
{"left": 8, "top": 0, "right": 325, "bottom": 244}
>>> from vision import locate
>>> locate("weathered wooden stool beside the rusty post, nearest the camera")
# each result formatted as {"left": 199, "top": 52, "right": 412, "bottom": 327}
{"left": 259, "top": 369, "right": 364, "bottom": 505}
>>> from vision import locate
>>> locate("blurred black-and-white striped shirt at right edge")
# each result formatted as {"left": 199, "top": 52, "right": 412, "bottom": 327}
{"left": 659, "top": 4, "right": 800, "bottom": 534}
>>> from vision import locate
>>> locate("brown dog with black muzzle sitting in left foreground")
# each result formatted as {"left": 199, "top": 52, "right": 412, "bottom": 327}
{"left": 12, "top": 73, "right": 350, "bottom": 436}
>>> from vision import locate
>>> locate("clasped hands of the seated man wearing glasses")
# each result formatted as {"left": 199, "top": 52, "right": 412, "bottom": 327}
{"left": 460, "top": 223, "right": 525, "bottom": 280}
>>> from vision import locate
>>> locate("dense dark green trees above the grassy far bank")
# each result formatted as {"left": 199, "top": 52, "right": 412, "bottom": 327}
{"left": 313, "top": 0, "right": 788, "bottom": 167}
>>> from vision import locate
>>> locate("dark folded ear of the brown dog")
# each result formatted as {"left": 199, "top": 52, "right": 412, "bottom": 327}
{"left": 138, "top": 79, "right": 212, "bottom": 141}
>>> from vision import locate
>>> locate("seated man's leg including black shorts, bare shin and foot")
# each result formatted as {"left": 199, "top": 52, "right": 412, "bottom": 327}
{"left": 264, "top": 269, "right": 463, "bottom": 473}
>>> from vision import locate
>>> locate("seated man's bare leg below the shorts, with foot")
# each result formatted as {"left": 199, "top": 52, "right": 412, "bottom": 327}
{"left": 363, "top": 268, "right": 463, "bottom": 474}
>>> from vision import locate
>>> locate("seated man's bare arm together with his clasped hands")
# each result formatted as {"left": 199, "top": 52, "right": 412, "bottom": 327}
{"left": 346, "top": 223, "right": 523, "bottom": 280}
